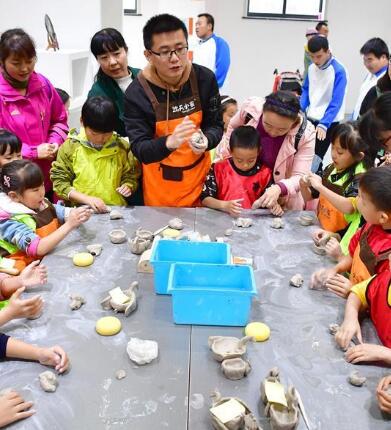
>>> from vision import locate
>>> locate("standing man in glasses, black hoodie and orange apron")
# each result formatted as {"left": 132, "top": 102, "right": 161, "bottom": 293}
{"left": 124, "top": 14, "right": 223, "bottom": 207}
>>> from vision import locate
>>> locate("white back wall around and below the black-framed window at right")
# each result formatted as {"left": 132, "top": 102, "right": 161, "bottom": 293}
{"left": 205, "top": 0, "right": 391, "bottom": 111}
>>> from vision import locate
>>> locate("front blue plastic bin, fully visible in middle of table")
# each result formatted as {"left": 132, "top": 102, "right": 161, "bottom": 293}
{"left": 168, "top": 263, "right": 257, "bottom": 326}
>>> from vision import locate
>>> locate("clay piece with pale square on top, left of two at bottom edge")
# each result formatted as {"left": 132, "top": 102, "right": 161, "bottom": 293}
{"left": 209, "top": 391, "right": 262, "bottom": 430}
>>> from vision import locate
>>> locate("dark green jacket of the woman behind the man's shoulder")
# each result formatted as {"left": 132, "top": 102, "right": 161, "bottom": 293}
{"left": 88, "top": 67, "right": 140, "bottom": 136}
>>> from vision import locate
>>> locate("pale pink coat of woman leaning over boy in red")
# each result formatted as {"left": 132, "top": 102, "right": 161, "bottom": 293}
{"left": 225, "top": 97, "right": 315, "bottom": 210}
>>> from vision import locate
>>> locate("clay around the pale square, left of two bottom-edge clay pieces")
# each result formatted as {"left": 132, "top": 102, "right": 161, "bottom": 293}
{"left": 209, "top": 390, "right": 262, "bottom": 430}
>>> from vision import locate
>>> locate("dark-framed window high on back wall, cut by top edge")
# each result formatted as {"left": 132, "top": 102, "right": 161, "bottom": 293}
{"left": 246, "top": 0, "right": 326, "bottom": 21}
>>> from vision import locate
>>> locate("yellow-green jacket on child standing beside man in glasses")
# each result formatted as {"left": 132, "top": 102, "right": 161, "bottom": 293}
{"left": 50, "top": 128, "right": 141, "bottom": 206}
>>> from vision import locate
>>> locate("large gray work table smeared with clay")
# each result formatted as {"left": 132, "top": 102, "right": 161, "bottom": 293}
{"left": 0, "top": 207, "right": 391, "bottom": 430}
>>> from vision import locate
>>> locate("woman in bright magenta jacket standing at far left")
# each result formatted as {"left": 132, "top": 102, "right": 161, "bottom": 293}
{"left": 0, "top": 28, "right": 68, "bottom": 196}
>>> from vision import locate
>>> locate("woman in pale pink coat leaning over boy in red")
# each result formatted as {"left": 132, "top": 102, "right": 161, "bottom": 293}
{"left": 223, "top": 91, "right": 315, "bottom": 210}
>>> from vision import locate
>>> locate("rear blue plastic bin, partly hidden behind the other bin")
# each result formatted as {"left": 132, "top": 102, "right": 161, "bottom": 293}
{"left": 150, "top": 239, "right": 231, "bottom": 294}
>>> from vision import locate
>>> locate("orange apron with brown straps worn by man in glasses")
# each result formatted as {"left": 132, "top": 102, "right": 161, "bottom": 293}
{"left": 137, "top": 68, "right": 211, "bottom": 207}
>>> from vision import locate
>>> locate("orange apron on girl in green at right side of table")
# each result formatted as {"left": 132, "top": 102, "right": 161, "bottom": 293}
{"left": 318, "top": 166, "right": 349, "bottom": 233}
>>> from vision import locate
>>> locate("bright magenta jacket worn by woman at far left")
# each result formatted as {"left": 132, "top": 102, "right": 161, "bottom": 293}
{"left": 0, "top": 72, "right": 68, "bottom": 191}
